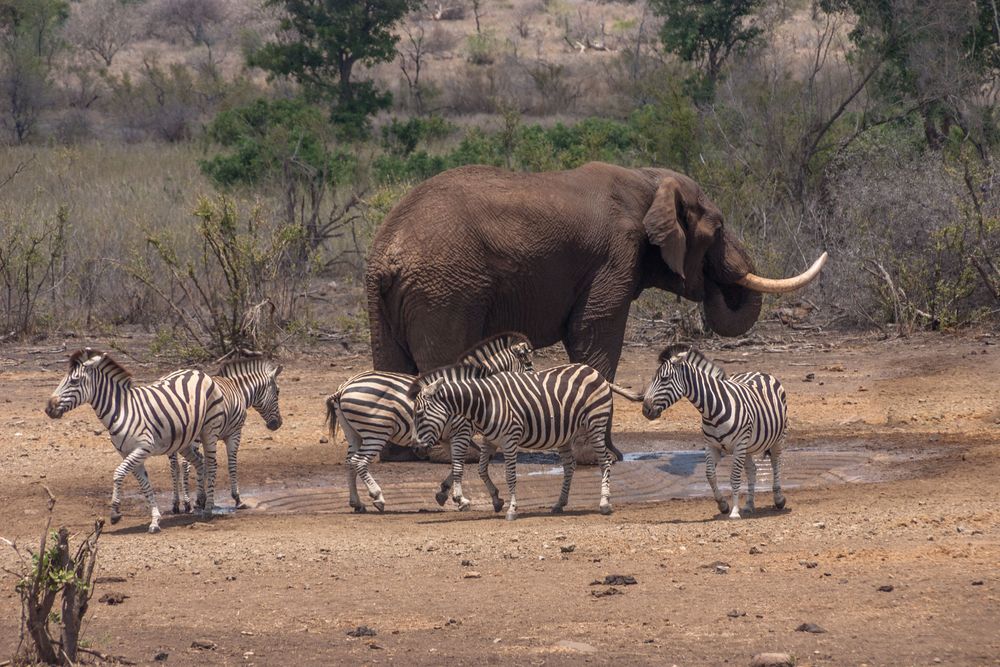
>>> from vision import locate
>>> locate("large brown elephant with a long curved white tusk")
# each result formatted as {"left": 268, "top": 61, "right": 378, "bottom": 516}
{"left": 365, "top": 162, "right": 826, "bottom": 462}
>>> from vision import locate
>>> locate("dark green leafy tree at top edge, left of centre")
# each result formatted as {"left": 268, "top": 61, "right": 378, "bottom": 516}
{"left": 248, "top": 0, "right": 423, "bottom": 136}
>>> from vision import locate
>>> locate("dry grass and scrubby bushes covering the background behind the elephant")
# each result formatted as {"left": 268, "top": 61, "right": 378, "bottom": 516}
{"left": 0, "top": 0, "right": 1000, "bottom": 356}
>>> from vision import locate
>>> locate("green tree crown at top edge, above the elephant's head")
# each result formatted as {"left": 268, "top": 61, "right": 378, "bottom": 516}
{"left": 650, "top": 0, "right": 763, "bottom": 92}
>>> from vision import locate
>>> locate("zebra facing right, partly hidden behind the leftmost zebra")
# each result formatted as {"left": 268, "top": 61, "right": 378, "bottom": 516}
{"left": 170, "top": 358, "right": 282, "bottom": 514}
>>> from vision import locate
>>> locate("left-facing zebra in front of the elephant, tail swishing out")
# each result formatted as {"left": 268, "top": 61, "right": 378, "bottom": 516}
{"left": 409, "top": 364, "right": 640, "bottom": 521}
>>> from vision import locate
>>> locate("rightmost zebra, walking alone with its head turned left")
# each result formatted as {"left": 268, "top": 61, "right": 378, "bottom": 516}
{"left": 642, "top": 345, "right": 788, "bottom": 519}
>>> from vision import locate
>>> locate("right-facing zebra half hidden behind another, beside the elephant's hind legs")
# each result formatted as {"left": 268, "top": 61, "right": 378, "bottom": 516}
{"left": 326, "top": 332, "right": 532, "bottom": 512}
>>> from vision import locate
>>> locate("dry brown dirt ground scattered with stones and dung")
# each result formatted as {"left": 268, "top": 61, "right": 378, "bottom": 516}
{"left": 0, "top": 333, "right": 1000, "bottom": 665}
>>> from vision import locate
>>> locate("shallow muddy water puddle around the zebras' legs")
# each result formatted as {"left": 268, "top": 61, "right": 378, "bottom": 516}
{"left": 244, "top": 434, "right": 940, "bottom": 513}
